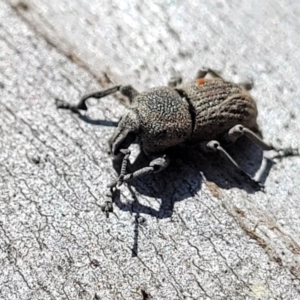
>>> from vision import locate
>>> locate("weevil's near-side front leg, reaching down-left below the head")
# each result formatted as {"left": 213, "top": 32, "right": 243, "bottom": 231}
{"left": 108, "top": 155, "right": 170, "bottom": 188}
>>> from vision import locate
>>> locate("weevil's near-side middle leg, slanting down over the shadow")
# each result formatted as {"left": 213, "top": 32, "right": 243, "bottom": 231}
{"left": 200, "top": 140, "right": 262, "bottom": 189}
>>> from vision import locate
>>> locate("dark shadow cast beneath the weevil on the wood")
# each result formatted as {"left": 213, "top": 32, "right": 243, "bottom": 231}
{"left": 113, "top": 137, "right": 272, "bottom": 219}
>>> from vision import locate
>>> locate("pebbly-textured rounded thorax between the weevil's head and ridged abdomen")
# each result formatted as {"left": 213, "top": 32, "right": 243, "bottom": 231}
{"left": 132, "top": 87, "right": 192, "bottom": 154}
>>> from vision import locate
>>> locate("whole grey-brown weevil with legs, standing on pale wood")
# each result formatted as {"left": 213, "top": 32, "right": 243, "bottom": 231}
{"left": 56, "top": 69, "right": 288, "bottom": 215}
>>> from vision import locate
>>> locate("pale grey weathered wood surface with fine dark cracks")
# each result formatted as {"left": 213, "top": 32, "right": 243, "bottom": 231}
{"left": 0, "top": 0, "right": 300, "bottom": 299}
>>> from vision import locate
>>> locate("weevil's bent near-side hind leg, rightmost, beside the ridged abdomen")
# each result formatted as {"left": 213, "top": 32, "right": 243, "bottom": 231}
{"left": 227, "top": 124, "right": 274, "bottom": 150}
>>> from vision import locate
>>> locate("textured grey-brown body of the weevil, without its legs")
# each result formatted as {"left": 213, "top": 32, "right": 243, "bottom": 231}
{"left": 111, "top": 78, "right": 258, "bottom": 155}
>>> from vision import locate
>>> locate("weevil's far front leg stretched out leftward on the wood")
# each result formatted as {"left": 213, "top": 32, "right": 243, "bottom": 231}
{"left": 56, "top": 85, "right": 138, "bottom": 112}
